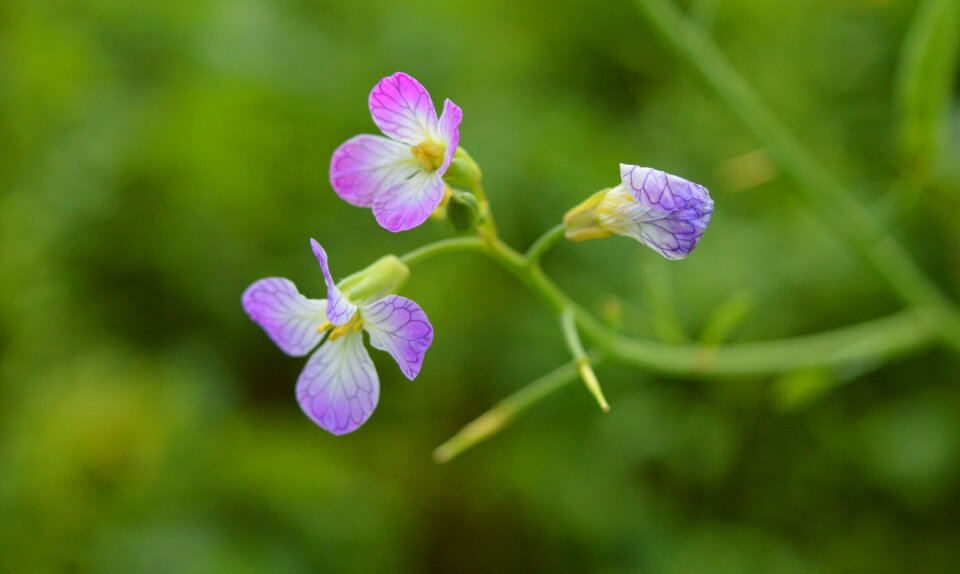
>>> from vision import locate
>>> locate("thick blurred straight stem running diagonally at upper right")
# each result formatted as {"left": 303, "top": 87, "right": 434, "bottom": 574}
{"left": 637, "top": 0, "right": 960, "bottom": 350}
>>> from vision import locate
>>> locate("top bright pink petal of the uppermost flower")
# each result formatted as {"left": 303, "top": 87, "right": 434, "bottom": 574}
{"left": 368, "top": 72, "right": 437, "bottom": 145}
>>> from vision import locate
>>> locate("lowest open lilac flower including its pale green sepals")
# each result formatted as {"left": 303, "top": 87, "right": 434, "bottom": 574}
{"left": 243, "top": 239, "right": 433, "bottom": 435}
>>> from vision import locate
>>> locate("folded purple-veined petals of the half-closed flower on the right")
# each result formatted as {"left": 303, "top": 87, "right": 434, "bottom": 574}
{"left": 605, "top": 164, "right": 713, "bottom": 259}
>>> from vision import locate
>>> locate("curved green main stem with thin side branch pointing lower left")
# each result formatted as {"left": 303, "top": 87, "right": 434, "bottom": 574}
{"left": 400, "top": 232, "right": 937, "bottom": 462}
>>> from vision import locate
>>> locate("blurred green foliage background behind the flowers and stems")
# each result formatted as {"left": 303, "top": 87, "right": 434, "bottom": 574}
{"left": 0, "top": 0, "right": 960, "bottom": 573}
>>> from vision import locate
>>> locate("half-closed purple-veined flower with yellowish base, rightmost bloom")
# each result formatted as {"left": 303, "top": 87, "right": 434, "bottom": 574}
{"left": 563, "top": 163, "right": 713, "bottom": 259}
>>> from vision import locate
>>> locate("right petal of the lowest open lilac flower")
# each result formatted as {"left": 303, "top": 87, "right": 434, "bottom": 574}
{"left": 360, "top": 295, "right": 433, "bottom": 381}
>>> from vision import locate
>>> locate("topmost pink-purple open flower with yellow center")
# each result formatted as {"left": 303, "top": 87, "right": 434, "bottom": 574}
{"left": 330, "top": 72, "right": 463, "bottom": 232}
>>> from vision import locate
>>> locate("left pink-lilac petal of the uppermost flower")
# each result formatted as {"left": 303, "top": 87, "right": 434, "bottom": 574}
{"left": 330, "top": 135, "right": 419, "bottom": 207}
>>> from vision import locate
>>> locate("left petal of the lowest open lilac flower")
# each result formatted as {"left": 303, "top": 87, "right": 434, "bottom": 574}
{"left": 242, "top": 277, "right": 327, "bottom": 357}
